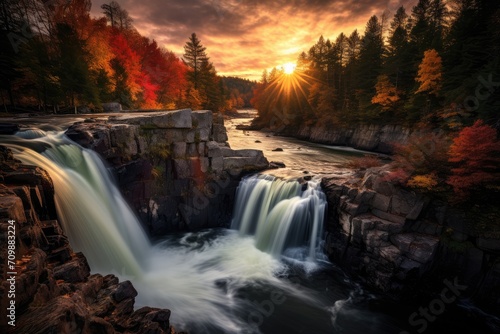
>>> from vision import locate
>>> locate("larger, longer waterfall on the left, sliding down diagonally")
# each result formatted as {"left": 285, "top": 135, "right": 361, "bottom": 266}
{"left": 2, "top": 131, "right": 151, "bottom": 276}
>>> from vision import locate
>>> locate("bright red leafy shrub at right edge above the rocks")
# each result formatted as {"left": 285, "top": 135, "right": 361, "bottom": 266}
{"left": 447, "top": 120, "right": 500, "bottom": 199}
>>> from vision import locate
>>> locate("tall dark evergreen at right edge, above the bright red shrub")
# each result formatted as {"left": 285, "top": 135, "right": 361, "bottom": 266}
{"left": 443, "top": 0, "right": 500, "bottom": 124}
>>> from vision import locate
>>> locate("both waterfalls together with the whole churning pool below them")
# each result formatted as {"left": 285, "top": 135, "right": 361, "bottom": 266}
{"left": 0, "top": 116, "right": 498, "bottom": 334}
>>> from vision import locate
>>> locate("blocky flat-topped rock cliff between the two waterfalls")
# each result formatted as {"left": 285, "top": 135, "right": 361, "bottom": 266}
{"left": 66, "top": 109, "right": 269, "bottom": 236}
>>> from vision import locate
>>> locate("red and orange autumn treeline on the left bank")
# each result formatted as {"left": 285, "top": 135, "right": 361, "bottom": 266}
{"left": 0, "top": 0, "right": 252, "bottom": 111}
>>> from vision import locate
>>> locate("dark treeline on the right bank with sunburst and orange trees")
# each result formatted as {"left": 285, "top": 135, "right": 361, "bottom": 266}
{"left": 252, "top": 0, "right": 500, "bottom": 129}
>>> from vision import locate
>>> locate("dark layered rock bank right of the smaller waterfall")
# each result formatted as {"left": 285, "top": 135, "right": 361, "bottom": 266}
{"left": 323, "top": 167, "right": 500, "bottom": 312}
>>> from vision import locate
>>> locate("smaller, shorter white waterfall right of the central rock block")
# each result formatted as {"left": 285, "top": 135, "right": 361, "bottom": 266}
{"left": 231, "top": 175, "right": 326, "bottom": 260}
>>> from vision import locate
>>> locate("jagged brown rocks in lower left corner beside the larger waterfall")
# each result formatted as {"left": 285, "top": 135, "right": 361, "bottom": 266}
{"left": 0, "top": 147, "right": 180, "bottom": 334}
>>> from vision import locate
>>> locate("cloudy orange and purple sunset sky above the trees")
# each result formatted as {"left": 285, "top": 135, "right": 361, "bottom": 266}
{"left": 91, "top": 0, "right": 417, "bottom": 80}
